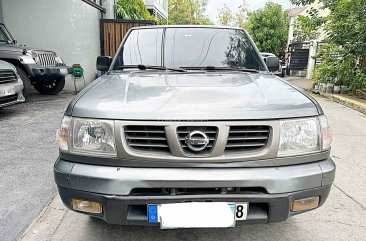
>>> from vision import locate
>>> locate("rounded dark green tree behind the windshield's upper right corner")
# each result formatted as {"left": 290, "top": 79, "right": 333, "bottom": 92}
{"left": 245, "top": 2, "right": 289, "bottom": 56}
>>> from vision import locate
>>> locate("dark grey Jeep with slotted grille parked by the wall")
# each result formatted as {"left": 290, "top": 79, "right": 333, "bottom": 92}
{"left": 0, "top": 24, "right": 72, "bottom": 95}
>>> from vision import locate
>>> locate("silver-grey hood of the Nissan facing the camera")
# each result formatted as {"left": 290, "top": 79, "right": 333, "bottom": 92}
{"left": 70, "top": 72, "right": 319, "bottom": 121}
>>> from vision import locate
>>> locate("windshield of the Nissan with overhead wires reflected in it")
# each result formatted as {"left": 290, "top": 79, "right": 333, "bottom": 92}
{"left": 113, "top": 27, "right": 266, "bottom": 71}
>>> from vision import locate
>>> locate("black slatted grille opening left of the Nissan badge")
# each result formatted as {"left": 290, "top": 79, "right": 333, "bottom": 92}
{"left": 124, "top": 126, "right": 170, "bottom": 153}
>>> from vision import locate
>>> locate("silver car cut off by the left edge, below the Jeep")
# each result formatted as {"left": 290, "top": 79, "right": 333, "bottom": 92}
{"left": 0, "top": 60, "right": 25, "bottom": 109}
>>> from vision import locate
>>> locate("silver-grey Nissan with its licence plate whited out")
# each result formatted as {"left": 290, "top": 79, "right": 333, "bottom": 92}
{"left": 54, "top": 26, "right": 335, "bottom": 229}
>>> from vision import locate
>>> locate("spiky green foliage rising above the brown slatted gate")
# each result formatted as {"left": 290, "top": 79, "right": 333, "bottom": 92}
{"left": 114, "top": 0, "right": 156, "bottom": 20}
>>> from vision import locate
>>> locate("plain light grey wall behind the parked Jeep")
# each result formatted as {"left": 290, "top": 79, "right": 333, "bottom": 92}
{"left": 3, "top": 0, "right": 114, "bottom": 90}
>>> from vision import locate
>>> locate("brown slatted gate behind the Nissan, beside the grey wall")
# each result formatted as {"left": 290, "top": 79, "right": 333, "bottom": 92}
{"left": 100, "top": 19, "right": 155, "bottom": 57}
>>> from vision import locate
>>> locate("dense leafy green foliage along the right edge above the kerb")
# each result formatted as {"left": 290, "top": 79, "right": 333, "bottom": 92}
{"left": 292, "top": 0, "right": 366, "bottom": 93}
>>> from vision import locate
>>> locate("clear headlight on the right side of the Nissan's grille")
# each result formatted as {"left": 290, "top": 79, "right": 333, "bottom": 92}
{"left": 278, "top": 118, "right": 320, "bottom": 157}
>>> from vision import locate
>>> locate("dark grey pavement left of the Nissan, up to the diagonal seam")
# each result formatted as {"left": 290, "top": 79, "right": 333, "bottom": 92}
{"left": 0, "top": 91, "right": 72, "bottom": 241}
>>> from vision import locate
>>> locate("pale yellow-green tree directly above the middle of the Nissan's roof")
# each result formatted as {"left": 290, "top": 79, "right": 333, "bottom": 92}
{"left": 168, "top": 0, "right": 213, "bottom": 25}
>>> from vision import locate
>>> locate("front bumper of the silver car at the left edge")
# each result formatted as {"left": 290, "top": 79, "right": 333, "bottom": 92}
{"left": 0, "top": 80, "right": 25, "bottom": 108}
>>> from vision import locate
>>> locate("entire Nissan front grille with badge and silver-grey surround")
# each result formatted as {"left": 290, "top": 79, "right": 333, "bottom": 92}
{"left": 120, "top": 120, "right": 278, "bottom": 162}
